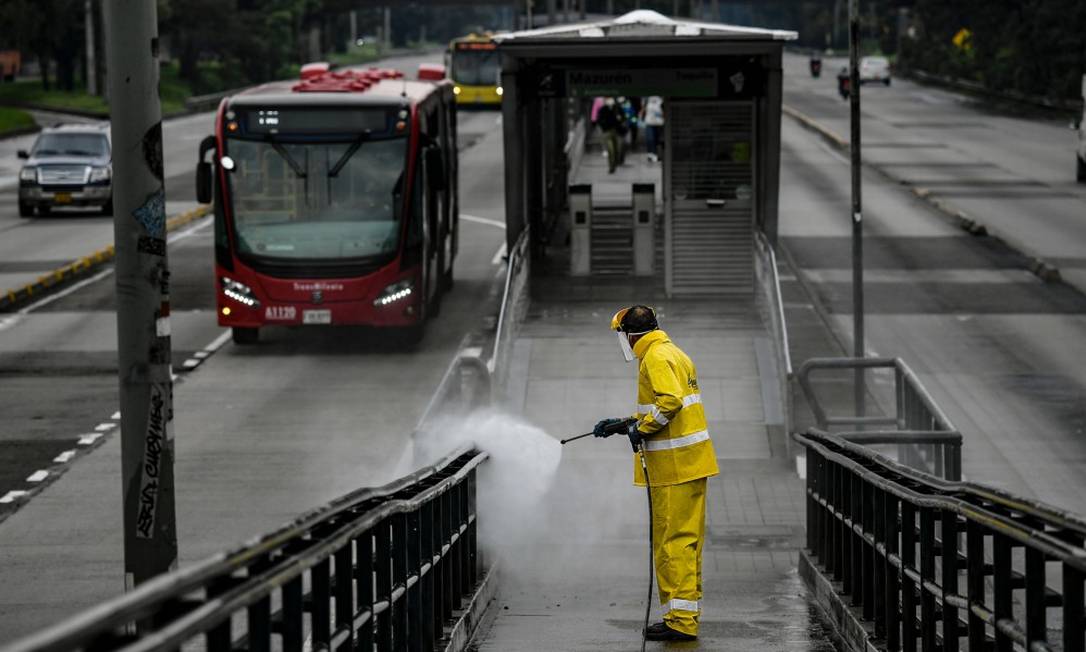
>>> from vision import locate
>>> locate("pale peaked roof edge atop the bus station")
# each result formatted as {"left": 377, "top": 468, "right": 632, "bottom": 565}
{"left": 493, "top": 9, "right": 799, "bottom": 46}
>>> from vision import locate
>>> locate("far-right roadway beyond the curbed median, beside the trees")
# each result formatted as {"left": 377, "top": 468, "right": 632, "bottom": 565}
{"left": 784, "top": 55, "right": 1086, "bottom": 290}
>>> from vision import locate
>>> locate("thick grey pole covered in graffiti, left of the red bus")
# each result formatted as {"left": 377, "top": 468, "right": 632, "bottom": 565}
{"left": 106, "top": 0, "right": 177, "bottom": 588}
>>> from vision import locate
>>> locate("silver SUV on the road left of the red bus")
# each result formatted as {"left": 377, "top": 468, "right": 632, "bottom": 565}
{"left": 18, "top": 124, "right": 113, "bottom": 217}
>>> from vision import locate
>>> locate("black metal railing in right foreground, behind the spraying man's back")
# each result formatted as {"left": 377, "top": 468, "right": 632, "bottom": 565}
{"left": 796, "top": 430, "right": 1086, "bottom": 652}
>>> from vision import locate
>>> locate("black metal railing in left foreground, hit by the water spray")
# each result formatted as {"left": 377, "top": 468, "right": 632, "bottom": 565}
{"left": 4, "top": 448, "right": 487, "bottom": 652}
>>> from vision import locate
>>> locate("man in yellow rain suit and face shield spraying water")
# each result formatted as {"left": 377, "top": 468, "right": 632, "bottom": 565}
{"left": 593, "top": 305, "right": 720, "bottom": 641}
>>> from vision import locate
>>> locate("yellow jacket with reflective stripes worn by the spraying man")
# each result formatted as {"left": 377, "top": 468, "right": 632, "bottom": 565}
{"left": 633, "top": 330, "right": 720, "bottom": 487}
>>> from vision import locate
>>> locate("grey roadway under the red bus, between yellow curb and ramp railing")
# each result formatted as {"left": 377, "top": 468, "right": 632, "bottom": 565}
{"left": 0, "top": 89, "right": 504, "bottom": 640}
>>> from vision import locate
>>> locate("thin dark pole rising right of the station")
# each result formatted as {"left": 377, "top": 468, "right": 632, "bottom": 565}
{"left": 848, "top": 0, "right": 867, "bottom": 416}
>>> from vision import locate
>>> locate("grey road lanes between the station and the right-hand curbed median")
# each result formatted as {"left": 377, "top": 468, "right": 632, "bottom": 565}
{"left": 781, "top": 113, "right": 1086, "bottom": 512}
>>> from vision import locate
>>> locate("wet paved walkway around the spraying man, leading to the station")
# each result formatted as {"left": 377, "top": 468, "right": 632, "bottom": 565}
{"left": 479, "top": 274, "right": 833, "bottom": 652}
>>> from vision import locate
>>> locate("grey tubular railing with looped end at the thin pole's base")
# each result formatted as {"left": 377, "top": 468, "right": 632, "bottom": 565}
{"left": 796, "top": 358, "right": 961, "bottom": 480}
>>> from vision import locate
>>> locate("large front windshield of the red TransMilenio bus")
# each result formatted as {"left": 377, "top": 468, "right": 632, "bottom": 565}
{"left": 228, "top": 138, "right": 407, "bottom": 260}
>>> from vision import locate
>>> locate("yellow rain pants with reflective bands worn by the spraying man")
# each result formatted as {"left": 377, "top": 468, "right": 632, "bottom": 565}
{"left": 651, "top": 478, "right": 707, "bottom": 636}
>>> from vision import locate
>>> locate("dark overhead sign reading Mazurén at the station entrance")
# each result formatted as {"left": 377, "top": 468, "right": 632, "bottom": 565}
{"left": 566, "top": 67, "right": 717, "bottom": 98}
